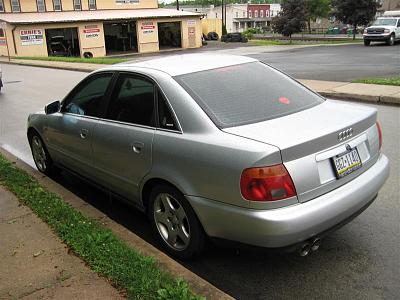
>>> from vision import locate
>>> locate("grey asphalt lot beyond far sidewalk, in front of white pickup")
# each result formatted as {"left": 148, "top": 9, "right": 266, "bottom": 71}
{"left": 250, "top": 43, "right": 400, "bottom": 81}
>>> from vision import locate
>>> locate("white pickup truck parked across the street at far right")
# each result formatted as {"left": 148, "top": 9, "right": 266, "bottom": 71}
{"left": 363, "top": 11, "right": 400, "bottom": 46}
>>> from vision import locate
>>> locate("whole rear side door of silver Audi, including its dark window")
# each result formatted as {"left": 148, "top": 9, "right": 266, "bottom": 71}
{"left": 93, "top": 73, "right": 156, "bottom": 200}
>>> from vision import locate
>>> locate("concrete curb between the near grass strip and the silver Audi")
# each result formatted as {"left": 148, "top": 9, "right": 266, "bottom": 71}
{"left": 0, "top": 147, "right": 234, "bottom": 299}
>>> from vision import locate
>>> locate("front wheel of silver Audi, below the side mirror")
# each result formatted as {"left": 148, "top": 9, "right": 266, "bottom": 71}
{"left": 29, "top": 131, "right": 55, "bottom": 177}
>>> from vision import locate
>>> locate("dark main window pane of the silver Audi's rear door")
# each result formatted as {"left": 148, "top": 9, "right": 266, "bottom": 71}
{"left": 106, "top": 74, "right": 155, "bottom": 127}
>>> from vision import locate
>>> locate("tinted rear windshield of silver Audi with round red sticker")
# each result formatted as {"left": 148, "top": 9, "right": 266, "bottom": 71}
{"left": 174, "top": 62, "right": 324, "bottom": 128}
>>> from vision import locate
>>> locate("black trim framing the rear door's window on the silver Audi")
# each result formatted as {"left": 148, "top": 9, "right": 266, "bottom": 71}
{"left": 100, "top": 71, "right": 182, "bottom": 133}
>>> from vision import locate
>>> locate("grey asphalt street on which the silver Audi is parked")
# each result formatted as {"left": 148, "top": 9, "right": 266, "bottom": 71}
{"left": 0, "top": 65, "right": 400, "bottom": 299}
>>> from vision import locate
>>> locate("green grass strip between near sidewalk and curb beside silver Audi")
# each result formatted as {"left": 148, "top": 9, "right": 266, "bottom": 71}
{"left": 0, "top": 154, "right": 202, "bottom": 300}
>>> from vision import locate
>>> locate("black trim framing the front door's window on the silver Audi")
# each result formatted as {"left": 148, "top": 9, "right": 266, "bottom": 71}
{"left": 60, "top": 71, "right": 117, "bottom": 119}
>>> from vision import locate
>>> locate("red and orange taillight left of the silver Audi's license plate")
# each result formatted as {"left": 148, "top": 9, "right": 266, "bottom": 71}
{"left": 240, "top": 164, "right": 296, "bottom": 201}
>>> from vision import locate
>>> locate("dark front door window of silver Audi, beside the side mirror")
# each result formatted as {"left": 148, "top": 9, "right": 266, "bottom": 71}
{"left": 62, "top": 73, "right": 112, "bottom": 117}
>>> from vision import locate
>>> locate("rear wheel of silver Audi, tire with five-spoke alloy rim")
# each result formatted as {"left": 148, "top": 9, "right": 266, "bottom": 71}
{"left": 147, "top": 184, "right": 205, "bottom": 259}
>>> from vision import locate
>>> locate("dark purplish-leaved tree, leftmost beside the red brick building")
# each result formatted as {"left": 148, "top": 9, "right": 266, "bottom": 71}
{"left": 272, "top": 0, "right": 306, "bottom": 39}
